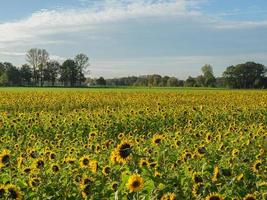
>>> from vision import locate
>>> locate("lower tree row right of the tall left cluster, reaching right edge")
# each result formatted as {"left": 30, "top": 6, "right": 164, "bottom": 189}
{"left": 86, "top": 62, "right": 267, "bottom": 88}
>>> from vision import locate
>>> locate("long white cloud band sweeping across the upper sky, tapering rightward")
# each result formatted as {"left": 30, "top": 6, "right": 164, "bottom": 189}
{"left": 0, "top": 0, "right": 267, "bottom": 48}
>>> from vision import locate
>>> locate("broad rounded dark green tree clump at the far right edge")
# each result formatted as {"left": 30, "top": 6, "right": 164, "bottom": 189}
{"left": 223, "top": 62, "right": 266, "bottom": 88}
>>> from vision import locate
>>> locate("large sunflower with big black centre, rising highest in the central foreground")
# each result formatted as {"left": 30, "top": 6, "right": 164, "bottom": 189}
{"left": 116, "top": 141, "right": 132, "bottom": 164}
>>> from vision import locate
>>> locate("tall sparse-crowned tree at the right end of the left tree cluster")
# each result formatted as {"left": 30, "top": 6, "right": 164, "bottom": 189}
{"left": 74, "top": 53, "right": 90, "bottom": 86}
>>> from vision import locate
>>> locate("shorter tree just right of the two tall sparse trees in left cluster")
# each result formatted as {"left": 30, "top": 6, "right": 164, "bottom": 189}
{"left": 44, "top": 61, "right": 60, "bottom": 86}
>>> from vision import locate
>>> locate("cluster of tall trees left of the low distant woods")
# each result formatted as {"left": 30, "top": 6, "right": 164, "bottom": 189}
{"left": 0, "top": 48, "right": 89, "bottom": 87}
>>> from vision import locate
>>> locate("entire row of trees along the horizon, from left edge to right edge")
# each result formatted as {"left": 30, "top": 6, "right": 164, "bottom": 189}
{"left": 0, "top": 48, "right": 267, "bottom": 88}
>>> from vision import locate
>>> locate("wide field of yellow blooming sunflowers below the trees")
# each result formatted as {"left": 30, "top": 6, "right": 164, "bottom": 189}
{"left": 0, "top": 88, "right": 267, "bottom": 200}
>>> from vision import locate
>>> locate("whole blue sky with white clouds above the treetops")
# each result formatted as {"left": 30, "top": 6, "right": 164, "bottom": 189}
{"left": 0, "top": 0, "right": 267, "bottom": 79}
